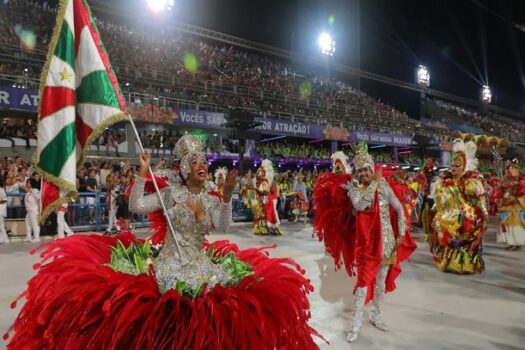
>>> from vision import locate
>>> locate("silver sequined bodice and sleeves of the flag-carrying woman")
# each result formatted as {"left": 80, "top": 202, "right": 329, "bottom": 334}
{"left": 129, "top": 177, "right": 232, "bottom": 291}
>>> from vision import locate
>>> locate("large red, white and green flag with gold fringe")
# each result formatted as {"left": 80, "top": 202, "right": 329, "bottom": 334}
{"left": 35, "top": 0, "right": 127, "bottom": 221}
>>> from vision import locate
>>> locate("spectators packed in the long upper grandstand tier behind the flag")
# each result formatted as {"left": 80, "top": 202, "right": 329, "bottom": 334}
{"left": 0, "top": 0, "right": 442, "bottom": 139}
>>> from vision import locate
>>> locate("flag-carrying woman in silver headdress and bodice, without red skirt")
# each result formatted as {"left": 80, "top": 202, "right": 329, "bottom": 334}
{"left": 129, "top": 137, "right": 237, "bottom": 290}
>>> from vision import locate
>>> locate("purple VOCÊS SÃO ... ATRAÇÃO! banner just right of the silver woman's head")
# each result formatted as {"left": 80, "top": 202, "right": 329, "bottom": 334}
{"left": 174, "top": 108, "right": 323, "bottom": 138}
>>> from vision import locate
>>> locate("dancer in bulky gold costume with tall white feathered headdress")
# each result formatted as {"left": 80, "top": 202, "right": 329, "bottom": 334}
{"left": 427, "top": 140, "right": 488, "bottom": 274}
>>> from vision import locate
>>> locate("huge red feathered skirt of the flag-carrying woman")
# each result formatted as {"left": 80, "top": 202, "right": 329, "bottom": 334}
{"left": 4, "top": 234, "right": 319, "bottom": 350}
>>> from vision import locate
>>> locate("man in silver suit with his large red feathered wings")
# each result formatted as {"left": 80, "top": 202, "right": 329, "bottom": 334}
{"left": 314, "top": 144, "right": 416, "bottom": 342}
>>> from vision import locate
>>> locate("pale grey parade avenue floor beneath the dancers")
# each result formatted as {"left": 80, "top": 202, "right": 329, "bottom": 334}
{"left": 0, "top": 223, "right": 525, "bottom": 350}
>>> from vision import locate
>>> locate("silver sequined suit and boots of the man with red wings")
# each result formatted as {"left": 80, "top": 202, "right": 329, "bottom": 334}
{"left": 344, "top": 179, "right": 406, "bottom": 342}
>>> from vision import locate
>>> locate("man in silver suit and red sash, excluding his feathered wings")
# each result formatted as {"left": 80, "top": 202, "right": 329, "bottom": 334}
{"left": 346, "top": 151, "right": 415, "bottom": 342}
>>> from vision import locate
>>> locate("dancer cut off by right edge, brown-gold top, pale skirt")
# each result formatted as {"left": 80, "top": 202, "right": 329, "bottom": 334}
{"left": 496, "top": 159, "right": 525, "bottom": 250}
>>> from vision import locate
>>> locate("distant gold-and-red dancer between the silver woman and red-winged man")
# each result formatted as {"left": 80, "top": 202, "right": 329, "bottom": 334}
{"left": 252, "top": 159, "right": 282, "bottom": 235}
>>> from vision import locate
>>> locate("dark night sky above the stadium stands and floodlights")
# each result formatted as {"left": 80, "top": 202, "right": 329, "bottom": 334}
{"left": 104, "top": 0, "right": 525, "bottom": 115}
